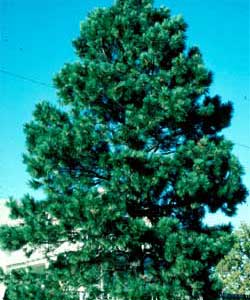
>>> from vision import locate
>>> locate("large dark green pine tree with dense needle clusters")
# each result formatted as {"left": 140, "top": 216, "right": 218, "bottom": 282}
{"left": 1, "top": 0, "right": 246, "bottom": 300}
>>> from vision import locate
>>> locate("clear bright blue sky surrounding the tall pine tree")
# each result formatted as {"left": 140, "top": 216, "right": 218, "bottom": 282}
{"left": 0, "top": 0, "right": 250, "bottom": 226}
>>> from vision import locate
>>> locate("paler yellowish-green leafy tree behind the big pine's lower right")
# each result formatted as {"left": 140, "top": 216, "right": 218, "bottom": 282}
{"left": 217, "top": 224, "right": 250, "bottom": 295}
